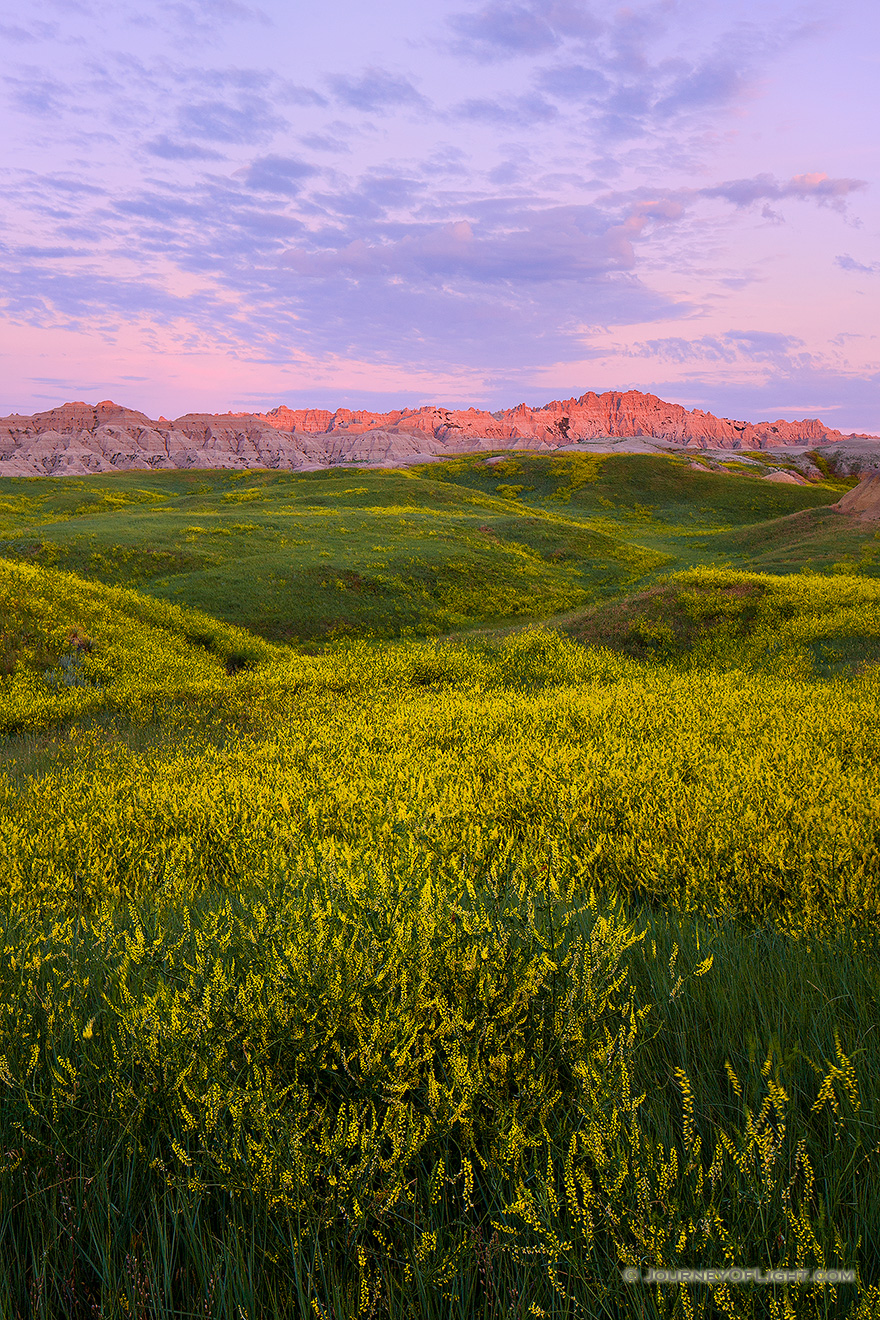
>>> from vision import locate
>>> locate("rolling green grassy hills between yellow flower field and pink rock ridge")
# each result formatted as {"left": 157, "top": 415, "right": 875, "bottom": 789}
{"left": 0, "top": 454, "right": 860, "bottom": 642}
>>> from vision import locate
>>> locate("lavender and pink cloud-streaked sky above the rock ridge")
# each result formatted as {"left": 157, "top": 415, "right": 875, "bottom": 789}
{"left": 0, "top": 0, "right": 880, "bottom": 433}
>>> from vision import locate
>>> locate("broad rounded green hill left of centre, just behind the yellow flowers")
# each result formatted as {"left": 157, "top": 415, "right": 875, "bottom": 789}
{"left": 0, "top": 470, "right": 660, "bottom": 640}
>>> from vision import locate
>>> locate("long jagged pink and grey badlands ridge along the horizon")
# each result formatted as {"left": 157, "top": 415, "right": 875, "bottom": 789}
{"left": 0, "top": 389, "right": 860, "bottom": 477}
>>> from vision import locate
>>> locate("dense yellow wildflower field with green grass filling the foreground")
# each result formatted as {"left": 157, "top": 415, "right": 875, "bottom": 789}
{"left": 0, "top": 456, "right": 880, "bottom": 1320}
